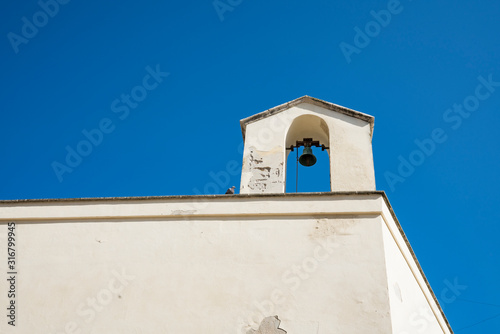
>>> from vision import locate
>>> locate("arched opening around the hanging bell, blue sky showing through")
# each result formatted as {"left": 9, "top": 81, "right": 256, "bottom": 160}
{"left": 285, "top": 115, "right": 331, "bottom": 193}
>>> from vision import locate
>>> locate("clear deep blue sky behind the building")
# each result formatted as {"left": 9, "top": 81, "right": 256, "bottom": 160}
{"left": 0, "top": 0, "right": 500, "bottom": 334}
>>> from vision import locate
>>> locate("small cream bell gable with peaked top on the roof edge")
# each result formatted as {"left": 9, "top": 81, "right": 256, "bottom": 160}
{"left": 240, "top": 96, "right": 375, "bottom": 194}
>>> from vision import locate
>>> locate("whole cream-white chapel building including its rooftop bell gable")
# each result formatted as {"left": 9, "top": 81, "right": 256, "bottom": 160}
{"left": 0, "top": 96, "right": 453, "bottom": 334}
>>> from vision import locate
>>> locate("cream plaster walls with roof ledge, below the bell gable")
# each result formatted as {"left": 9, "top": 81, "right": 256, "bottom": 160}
{"left": 0, "top": 193, "right": 448, "bottom": 334}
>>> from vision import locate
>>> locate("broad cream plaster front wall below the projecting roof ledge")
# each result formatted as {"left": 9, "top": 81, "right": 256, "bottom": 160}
{"left": 0, "top": 217, "right": 390, "bottom": 334}
